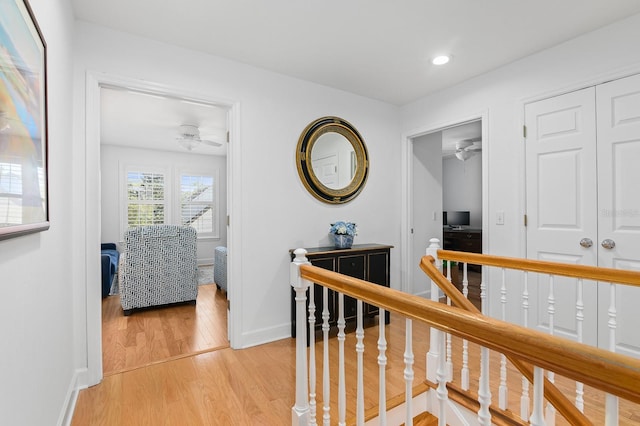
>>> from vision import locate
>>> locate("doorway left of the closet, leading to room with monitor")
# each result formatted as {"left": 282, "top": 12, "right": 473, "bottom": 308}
{"left": 403, "top": 115, "right": 487, "bottom": 297}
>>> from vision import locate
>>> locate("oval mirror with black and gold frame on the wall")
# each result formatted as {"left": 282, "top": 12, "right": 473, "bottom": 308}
{"left": 296, "top": 117, "right": 369, "bottom": 204}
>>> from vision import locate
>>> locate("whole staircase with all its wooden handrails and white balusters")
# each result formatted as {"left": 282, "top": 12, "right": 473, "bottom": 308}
{"left": 291, "top": 240, "right": 640, "bottom": 425}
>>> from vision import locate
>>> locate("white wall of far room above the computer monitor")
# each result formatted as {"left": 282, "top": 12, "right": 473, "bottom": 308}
{"left": 442, "top": 153, "right": 482, "bottom": 228}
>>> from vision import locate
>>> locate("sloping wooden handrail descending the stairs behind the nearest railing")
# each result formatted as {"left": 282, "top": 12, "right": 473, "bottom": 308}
{"left": 420, "top": 256, "right": 592, "bottom": 425}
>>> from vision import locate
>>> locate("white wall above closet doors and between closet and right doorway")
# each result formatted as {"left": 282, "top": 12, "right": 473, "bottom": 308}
{"left": 401, "top": 15, "right": 640, "bottom": 320}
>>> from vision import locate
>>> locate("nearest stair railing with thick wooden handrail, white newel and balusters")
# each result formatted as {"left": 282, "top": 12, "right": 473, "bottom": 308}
{"left": 291, "top": 249, "right": 640, "bottom": 425}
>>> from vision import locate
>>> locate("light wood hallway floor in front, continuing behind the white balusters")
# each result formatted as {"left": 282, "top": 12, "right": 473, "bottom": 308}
{"left": 72, "top": 304, "right": 640, "bottom": 426}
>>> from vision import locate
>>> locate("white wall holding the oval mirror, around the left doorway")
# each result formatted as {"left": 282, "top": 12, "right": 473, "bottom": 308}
{"left": 75, "top": 19, "right": 400, "bottom": 358}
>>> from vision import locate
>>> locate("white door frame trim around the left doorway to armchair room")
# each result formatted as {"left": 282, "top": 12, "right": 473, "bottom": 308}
{"left": 81, "top": 72, "right": 242, "bottom": 386}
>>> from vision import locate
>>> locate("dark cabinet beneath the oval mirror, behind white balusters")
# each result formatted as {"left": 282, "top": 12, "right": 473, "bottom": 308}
{"left": 291, "top": 244, "right": 393, "bottom": 337}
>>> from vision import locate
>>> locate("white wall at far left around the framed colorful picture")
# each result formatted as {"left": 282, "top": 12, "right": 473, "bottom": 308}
{"left": 0, "top": 0, "right": 79, "bottom": 425}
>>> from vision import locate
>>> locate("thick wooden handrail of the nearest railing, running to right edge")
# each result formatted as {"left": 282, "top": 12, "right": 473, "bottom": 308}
{"left": 300, "top": 265, "right": 640, "bottom": 403}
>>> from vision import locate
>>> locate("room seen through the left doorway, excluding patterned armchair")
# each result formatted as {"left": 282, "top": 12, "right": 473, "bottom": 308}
{"left": 100, "top": 85, "right": 229, "bottom": 375}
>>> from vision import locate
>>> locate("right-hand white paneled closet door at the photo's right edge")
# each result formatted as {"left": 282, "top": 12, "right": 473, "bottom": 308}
{"left": 596, "top": 75, "right": 640, "bottom": 357}
